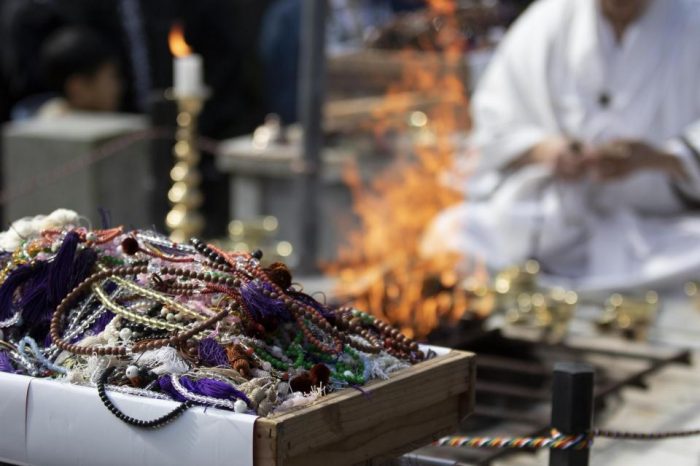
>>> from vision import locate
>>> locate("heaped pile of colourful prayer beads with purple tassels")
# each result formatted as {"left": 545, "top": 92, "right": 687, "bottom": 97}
{"left": 0, "top": 224, "right": 426, "bottom": 428}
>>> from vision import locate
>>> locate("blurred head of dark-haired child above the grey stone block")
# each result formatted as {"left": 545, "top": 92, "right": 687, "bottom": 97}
{"left": 30, "top": 27, "right": 122, "bottom": 117}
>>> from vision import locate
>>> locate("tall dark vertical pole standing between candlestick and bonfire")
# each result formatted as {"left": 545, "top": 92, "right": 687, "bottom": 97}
{"left": 297, "top": 0, "right": 328, "bottom": 274}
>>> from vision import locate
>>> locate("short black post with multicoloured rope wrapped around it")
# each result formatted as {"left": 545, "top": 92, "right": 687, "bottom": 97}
{"left": 549, "top": 363, "right": 593, "bottom": 466}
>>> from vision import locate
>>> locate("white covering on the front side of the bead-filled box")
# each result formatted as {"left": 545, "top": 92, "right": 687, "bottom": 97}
{"left": 0, "top": 372, "right": 257, "bottom": 466}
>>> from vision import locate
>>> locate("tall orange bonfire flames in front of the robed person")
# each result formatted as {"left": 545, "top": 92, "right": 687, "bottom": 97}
{"left": 337, "top": 1, "right": 469, "bottom": 338}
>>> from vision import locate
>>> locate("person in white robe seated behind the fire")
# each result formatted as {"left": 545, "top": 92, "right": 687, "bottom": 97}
{"left": 422, "top": 0, "right": 700, "bottom": 291}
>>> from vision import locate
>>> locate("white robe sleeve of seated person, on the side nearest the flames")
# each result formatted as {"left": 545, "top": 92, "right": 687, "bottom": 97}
{"left": 472, "top": 0, "right": 567, "bottom": 173}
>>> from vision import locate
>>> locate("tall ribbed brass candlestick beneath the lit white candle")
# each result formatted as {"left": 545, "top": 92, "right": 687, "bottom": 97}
{"left": 165, "top": 96, "right": 204, "bottom": 242}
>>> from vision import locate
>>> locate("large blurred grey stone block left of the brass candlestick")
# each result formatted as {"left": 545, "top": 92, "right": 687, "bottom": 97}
{"left": 2, "top": 114, "right": 156, "bottom": 227}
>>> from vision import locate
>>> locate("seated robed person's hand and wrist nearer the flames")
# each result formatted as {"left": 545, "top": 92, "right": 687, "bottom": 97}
{"left": 519, "top": 137, "right": 587, "bottom": 180}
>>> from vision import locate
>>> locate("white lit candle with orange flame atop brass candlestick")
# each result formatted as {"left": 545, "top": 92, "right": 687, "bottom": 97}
{"left": 168, "top": 24, "right": 204, "bottom": 97}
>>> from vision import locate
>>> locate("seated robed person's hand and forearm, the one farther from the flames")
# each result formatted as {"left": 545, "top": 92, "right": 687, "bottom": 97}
{"left": 584, "top": 140, "right": 687, "bottom": 181}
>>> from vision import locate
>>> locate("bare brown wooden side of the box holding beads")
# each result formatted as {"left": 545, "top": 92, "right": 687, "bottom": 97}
{"left": 253, "top": 351, "right": 475, "bottom": 466}
